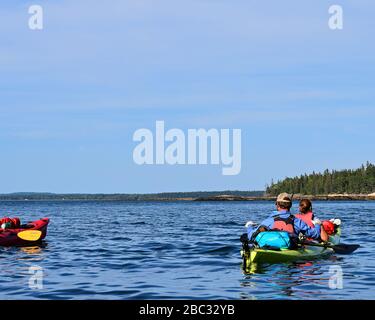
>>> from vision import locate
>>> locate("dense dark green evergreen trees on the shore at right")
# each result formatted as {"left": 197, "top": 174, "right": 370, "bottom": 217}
{"left": 266, "top": 162, "right": 375, "bottom": 196}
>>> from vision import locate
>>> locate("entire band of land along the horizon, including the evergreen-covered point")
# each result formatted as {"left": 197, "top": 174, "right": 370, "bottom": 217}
{"left": 0, "top": 162, "right": 375, "bottom": 201}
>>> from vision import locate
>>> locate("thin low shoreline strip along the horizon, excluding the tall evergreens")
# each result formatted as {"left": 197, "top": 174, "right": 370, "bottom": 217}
{"left": 0, "top": 191, "right": 375, "bottom": 202}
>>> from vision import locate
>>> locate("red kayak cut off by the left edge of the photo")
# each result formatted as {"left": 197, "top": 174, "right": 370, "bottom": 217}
{"left": 0, "top": 218, "right": 49, "bottom": 247}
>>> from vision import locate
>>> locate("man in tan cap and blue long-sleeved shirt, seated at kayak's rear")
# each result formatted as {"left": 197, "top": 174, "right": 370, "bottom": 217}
{"left": 246, "top": 193, "right": 328, "bottom": 241}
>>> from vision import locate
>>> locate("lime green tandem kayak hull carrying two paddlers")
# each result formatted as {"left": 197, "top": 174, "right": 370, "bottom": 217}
{"left": 241, "top": 229, "right": 341, "bottom": 269}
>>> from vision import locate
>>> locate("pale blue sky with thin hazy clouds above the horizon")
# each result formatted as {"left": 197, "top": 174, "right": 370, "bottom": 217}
{"left": 0, "top": 0, "right": 375, "bottom": 193}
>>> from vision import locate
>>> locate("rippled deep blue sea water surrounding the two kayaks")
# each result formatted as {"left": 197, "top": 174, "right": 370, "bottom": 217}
{"left": 0, "top": 202, "right": 375, "bottom": 299}
